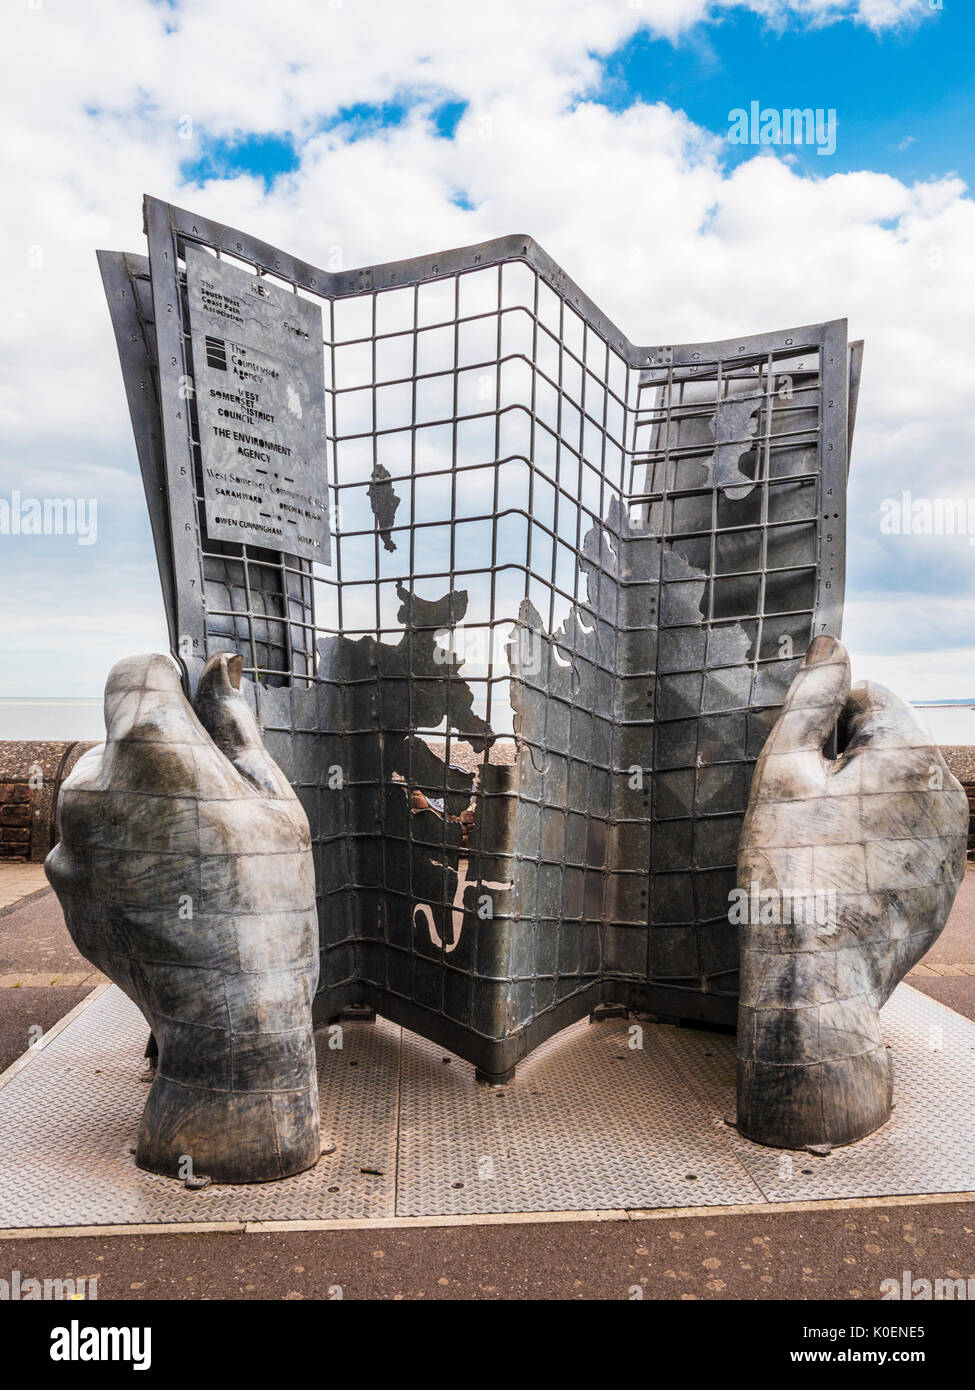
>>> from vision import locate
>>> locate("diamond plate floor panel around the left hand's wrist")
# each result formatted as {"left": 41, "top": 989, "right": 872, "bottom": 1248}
{"left": 0, "top": 987, "right": 401, "bottom": 1227}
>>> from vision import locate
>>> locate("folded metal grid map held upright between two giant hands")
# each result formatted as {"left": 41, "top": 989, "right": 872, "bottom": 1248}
{"left": 103, "top": 199, "right": 858, "bottom": 1074}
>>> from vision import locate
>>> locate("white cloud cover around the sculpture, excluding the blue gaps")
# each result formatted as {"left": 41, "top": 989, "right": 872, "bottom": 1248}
{"left": 0, "top": 0, "right": 975, "bottom": 706}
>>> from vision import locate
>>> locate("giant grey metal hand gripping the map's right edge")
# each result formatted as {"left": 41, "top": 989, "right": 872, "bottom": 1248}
{"left": 733, "top": 637, "right": 968, "bottom": 1148}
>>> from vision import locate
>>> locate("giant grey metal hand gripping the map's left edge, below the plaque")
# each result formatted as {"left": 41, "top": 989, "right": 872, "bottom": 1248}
{"left": 46, "top": 653, "right": 320, "bottom": 1183}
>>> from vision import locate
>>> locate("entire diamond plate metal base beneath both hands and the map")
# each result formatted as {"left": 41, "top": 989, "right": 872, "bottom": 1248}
{"left": 0, "top": 986, "right": 975, "bottom": 1229}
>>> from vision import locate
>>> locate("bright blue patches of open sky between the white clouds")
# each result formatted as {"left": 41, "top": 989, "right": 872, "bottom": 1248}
{"left": 176, "top": 0, "right": 975, "bottom": 186}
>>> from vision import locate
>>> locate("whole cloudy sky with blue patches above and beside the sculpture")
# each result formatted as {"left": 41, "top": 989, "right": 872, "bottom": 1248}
{"left": 0, "top": 0, "right": 975, "bottom": 717}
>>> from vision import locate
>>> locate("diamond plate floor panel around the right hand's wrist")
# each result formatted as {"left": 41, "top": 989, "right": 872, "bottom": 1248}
{"left": 650, "top": 984, "right": 975, "bottom": 1202}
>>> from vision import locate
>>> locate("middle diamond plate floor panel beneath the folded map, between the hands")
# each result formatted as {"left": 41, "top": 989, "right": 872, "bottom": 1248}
{"left": 396, "top": 1020, "right": 761, "bottom": 1216}
